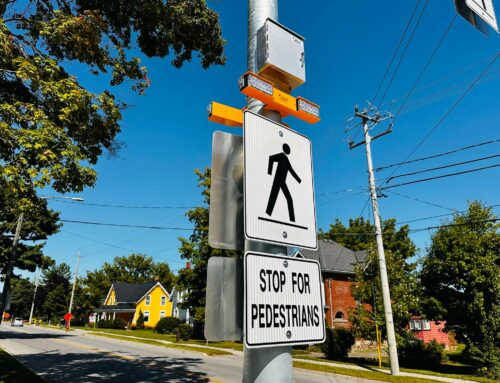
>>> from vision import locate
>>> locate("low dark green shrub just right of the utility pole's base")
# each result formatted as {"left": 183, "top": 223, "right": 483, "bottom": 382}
{"left": 398, "top": 334, "right": 446, "bottom": 369}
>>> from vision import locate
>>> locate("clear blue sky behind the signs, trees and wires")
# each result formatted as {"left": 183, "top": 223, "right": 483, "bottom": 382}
{"left": 21, "top": 0, "right": 500, "bottom": 280}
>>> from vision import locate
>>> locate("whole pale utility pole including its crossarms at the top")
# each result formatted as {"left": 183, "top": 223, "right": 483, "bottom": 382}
{"left": 349, "top": 106, "right": 399, "bottom": 375}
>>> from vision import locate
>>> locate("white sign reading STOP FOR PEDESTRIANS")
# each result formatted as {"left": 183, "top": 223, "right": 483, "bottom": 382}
{"left": 244, "top": 252, "right": 325, "bottom": 348}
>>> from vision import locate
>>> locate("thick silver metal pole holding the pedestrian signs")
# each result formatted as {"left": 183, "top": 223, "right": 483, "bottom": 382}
{"left": 243, "top": 0, "right": 293, "bottom": 383}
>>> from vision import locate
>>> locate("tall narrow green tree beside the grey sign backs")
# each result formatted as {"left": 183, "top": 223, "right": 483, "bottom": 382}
{"left": 178, "top": 168, "right": 238, "bottom": 322}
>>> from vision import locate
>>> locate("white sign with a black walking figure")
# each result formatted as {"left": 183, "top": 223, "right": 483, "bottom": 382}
{"left": 243, "top": 111, "right": 318, "bottom": 249}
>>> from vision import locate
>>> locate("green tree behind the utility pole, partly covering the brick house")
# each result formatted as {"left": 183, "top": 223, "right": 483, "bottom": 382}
{"left": 320, "top": 218, "right": 420, "bottom": 339}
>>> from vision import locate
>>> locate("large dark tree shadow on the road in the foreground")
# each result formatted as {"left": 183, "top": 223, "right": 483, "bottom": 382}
{"left": 17, "top": 351, "right": 209, "bottom": 383}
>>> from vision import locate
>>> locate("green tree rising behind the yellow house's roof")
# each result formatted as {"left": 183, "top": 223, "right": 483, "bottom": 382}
{"left": 81, "top": 254, "right": 175, "bottom": 307}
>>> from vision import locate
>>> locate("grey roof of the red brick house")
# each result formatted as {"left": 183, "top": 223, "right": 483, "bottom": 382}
{"left": 300, "top": 239, "right": 368, "bottom": 274}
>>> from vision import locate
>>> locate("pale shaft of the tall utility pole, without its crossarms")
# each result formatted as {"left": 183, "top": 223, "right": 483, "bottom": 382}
{"left": 363, "top": 119, "right": 399, "bottom": 375}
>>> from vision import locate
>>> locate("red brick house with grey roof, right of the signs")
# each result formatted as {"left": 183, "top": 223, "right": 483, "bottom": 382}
{"left": 301, "top": 240, "right": 368, "bottom": 327}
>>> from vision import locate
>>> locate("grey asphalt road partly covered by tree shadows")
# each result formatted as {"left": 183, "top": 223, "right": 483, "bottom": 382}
{"left": 0, "top": 325, "right": 374, "bottom": 383}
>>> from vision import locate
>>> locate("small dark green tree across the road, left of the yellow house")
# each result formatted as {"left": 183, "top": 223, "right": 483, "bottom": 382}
{"left": 37, "top": 263, "right": 71, "bottom": 321}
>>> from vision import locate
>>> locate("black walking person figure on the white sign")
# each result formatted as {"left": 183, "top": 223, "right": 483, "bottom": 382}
{"left": 266, "top": 144, "right": 302, "bottom": 222}
